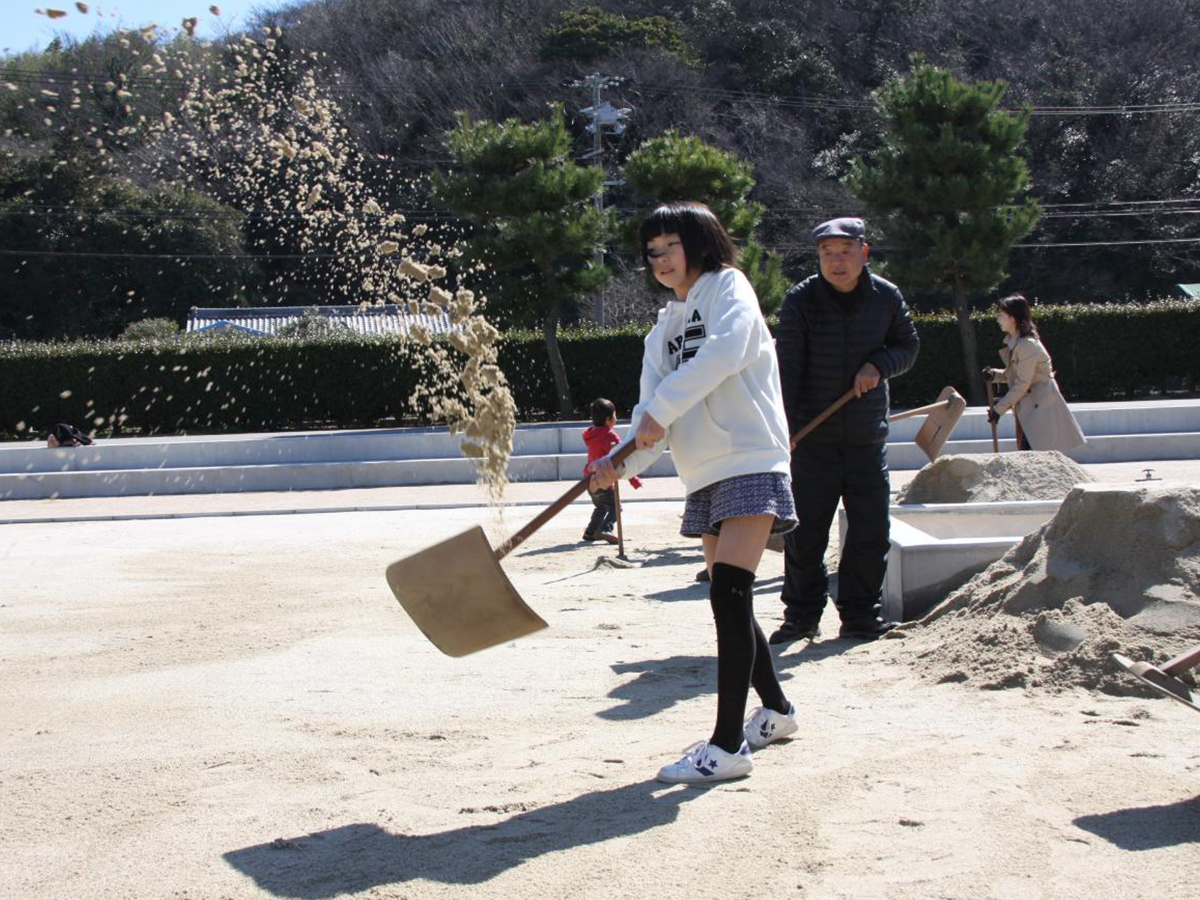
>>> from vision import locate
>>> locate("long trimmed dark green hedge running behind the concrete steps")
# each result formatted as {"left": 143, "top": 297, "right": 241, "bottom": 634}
{"left": 0, "top": 300, "right": 1200, "bottom": 438}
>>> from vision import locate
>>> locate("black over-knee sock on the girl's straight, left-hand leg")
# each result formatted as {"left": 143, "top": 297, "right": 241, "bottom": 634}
{"left": 708, "top": 563, "right": 770, "bottom": 754}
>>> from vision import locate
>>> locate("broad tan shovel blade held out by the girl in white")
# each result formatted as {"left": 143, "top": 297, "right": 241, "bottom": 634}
{"left": 388, "top": 526, "right": 546, "bottom": 656}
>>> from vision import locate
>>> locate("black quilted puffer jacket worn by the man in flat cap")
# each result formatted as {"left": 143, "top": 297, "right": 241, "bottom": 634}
{"left": 775, "top": 269, "right": 920, "bottom": 446}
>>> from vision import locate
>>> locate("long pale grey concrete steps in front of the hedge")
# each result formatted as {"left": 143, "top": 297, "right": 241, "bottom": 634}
{"left": 0, "top": 401, "right": 1200, "bottom": 499}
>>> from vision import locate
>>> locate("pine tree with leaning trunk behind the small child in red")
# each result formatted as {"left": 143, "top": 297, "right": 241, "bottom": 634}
{"left": 434, "top": 106, "right": 608, "bottom": 418}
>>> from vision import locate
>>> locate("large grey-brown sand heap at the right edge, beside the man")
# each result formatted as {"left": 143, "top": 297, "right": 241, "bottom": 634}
{"left": 894, "top": 485, "right": 1200, "bottom": 696}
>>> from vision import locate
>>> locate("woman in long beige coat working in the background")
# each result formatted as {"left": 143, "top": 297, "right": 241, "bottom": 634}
{"left": 984, "top": 294, "right": 1086, "bottom": 450}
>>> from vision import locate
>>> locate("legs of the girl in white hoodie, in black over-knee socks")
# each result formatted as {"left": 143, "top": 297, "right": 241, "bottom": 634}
{"left": 703, "top": 515, "right": 788, "bottom": 754}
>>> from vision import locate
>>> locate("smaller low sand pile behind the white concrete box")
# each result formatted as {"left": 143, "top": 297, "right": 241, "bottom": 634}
{"left": 896, "top": 450, "right": 1096, "bottom": 503}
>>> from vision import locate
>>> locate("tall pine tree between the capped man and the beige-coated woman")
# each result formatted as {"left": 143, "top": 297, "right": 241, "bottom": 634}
{"left": 847, "top": 56, "right": 1040, "bottom": 404}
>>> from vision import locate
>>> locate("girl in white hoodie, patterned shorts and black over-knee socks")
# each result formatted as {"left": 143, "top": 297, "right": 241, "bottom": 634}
{"left": 592, "top": 203, "right": 799, "bottom": 784}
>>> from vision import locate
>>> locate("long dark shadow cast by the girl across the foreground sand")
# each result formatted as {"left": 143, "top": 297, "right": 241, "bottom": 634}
{"left": 224, "top": 781, "right": 704, "bottom": 900}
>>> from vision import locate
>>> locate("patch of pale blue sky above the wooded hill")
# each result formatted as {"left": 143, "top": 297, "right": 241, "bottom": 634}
{"left": 0, "top": 0, "right": 261, "bottom": 55}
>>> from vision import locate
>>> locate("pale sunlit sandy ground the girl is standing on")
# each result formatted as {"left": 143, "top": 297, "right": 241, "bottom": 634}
{"left": 0, "top": 467, "right": 1200, "bottom": 900}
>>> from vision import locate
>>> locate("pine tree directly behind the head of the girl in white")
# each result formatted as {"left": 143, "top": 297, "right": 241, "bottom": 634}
{"left": 624, "top": 131, "right": 787, "bottom": 312}
